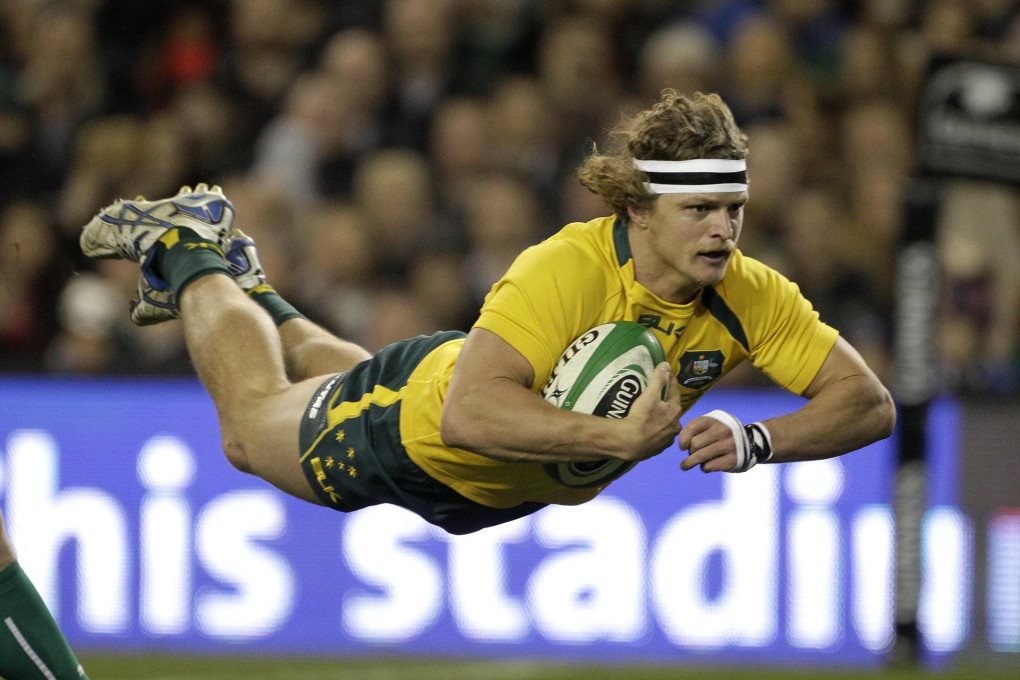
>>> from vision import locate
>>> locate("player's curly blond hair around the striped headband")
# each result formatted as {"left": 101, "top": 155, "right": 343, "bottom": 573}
{"left": 577, "top": 89, "right": 748, "bottom": 219}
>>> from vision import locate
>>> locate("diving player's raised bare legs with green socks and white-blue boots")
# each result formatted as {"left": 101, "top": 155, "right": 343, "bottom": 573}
{"left": 81, "top": 185, "right": 367, "bottom": 503}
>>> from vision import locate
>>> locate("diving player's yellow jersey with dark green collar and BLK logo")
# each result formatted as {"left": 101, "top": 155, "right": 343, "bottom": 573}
{"left": 400, "top": 217, "right": 837, "bottom": 508}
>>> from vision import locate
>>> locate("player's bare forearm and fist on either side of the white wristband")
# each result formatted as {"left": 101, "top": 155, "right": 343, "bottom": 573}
{"left": 680, "top": 337, "right": 896, "bottom": 472}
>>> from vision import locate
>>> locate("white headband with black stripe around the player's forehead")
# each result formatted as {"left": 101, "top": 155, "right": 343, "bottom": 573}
{"left": 634, "top": 158, "right": 748, "bottom": 194}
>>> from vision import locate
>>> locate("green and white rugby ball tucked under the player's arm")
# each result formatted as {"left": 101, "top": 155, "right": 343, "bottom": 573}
{"left": 542, "top": 321, "right": 666, "bottom": 488}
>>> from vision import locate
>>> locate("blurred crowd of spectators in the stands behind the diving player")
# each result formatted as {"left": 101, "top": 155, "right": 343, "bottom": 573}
{"left": 0, "top": 0, "right": 1020, "bottom": 394}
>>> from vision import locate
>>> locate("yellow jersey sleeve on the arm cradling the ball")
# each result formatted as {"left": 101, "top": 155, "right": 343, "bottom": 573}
{"left": 474, "top": 238, "right": 606, "bottom": 385}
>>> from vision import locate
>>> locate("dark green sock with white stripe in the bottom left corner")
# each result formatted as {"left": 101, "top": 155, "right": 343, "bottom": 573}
{"left": 0, "top": 562, "right": 88, "bottom": 680}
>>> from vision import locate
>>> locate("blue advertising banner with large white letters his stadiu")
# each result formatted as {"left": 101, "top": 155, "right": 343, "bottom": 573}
{"left": 0, "top": 377, "right": 973, "bottom": 666}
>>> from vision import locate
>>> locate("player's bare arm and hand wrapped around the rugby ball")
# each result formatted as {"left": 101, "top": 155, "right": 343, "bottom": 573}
{"left": 441, "top": 328, "right": 680, "bottom": 463}
